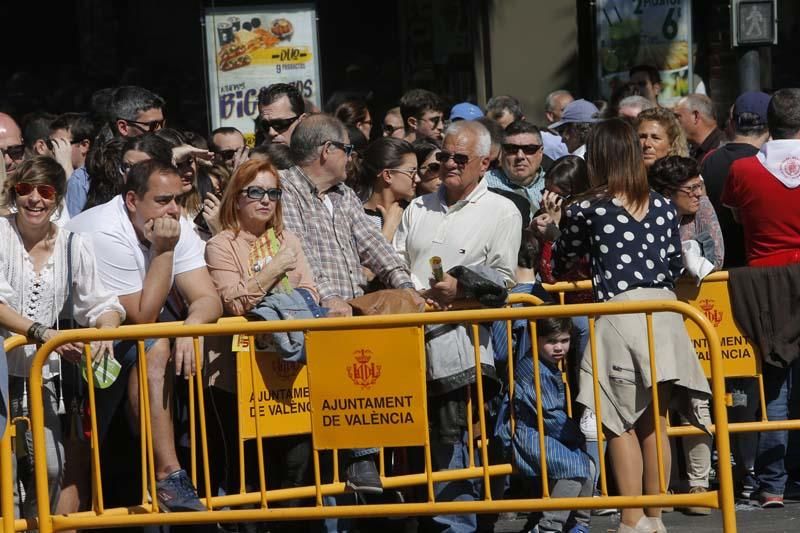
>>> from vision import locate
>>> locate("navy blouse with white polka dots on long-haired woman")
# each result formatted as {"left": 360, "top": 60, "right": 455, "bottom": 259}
{"left": 559, "top": 191, "right": 683, "bottom": 302}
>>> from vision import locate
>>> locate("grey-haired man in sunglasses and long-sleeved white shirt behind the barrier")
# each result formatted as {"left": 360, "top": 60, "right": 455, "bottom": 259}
{"left": 393, "top": 120, "right": 522, "bottom": 532}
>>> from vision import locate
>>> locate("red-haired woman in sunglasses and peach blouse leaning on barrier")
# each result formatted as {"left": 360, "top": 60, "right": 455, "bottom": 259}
{"left": 206, "top": 159, "right": 319, "bottom": 502}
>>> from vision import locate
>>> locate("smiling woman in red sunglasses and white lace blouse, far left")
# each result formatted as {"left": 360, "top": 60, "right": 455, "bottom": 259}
{"left": 0, "top": 156, "right": 125, "bottom": 518}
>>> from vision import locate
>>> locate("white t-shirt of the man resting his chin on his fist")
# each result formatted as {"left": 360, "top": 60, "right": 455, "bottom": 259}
{"left": 66, "top": 195, "right": 206, "bottom": 296}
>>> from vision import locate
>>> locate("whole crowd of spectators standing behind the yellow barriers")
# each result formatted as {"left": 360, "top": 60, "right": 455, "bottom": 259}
{"left": 0, "top": 60, "right": 800, "bottom": 533}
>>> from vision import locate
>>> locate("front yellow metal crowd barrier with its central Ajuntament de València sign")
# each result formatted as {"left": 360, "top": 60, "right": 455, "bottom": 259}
{"left": 21, "top": 300, "right": 736, "bottom": 533}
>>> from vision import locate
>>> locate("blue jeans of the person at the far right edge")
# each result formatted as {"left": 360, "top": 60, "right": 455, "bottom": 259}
{"left": 755, "top": 360, "right": 800, "bottom": 495}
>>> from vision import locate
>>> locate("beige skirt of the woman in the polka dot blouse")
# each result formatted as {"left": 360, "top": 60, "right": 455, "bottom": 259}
{"left": 577, "top": 289, "right": 711, "bottom": 435}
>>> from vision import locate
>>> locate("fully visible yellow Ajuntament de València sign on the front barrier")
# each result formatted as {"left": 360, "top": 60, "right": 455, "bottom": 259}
{"left": 306, "top": 327, "right": 428, "bottom": 449}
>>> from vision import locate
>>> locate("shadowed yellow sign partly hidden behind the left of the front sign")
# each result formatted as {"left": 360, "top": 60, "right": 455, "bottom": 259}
{"left": 236, "top": 352, "right": 311, "bottom": 439}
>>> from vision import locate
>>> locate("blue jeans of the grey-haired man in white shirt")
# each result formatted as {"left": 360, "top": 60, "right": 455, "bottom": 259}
{"left": 431, "top": 429, "right": 481, "bottom": 533}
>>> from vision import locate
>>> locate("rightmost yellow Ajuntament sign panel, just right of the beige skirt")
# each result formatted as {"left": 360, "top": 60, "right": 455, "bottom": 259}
{"left": 676, "top": 280, "right": 759, "bottom": 377}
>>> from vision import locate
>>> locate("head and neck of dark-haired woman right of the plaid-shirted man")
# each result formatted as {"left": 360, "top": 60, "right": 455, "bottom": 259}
{"left": 358, "top": 137, "right": 419, "bottom": 242}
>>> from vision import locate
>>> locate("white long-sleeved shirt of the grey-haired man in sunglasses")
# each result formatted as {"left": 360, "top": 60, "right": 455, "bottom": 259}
{"left": 393, "top": 180, "right": 522, "bottom": 289}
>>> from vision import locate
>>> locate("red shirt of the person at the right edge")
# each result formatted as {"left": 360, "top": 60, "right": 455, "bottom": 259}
{"left": 722, "top": 156, "right": 800, "bottom": 264}
